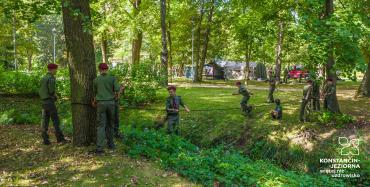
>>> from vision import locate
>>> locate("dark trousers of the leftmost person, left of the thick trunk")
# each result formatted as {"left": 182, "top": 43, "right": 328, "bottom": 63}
{"left": 41, "top": 101, "right": 64, "bottom": 143}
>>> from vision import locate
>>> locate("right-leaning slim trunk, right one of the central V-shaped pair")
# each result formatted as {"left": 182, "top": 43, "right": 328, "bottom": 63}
{"left": 198, "top": 0, "right": 215, "bottom": 82}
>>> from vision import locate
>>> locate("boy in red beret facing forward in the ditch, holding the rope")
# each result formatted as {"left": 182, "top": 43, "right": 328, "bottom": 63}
{"left": 166, "top": 86, "right": 190, "bottom": 135}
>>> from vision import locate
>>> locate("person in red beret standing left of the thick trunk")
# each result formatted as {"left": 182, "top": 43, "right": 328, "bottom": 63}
{"left": 39, "top": 63, "right": 67, "bottom": 145}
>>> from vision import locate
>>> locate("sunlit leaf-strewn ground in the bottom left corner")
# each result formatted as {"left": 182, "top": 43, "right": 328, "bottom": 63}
{"left": 0, "top": 125, "right": 195, "bottom": 186}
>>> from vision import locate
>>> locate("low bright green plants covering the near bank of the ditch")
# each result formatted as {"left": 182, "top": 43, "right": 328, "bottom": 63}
{"left": 123, "top": 128, "right": 344, "bottom": 186}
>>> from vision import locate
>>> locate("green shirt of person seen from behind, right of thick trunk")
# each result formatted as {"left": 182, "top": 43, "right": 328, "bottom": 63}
{"left": 93, "top": 74, "right": 119, "bottom": 101}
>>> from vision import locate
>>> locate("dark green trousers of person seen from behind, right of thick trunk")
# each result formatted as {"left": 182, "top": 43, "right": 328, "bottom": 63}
{"left": 96, "top": 101, "right": 115, "bottom": 150}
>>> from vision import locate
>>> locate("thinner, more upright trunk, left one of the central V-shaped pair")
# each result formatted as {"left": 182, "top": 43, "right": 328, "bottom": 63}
{"left": 193, "top": 0, "right": 204, "bottom": 82}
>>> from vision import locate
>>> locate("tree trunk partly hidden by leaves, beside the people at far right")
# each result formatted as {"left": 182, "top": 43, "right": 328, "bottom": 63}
{"left": 325, "top": 0, "right": 340, "bottom": 113}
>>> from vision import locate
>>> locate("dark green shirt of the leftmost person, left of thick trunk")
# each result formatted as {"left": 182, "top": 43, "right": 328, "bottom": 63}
{"left": 39, "top": 73, "right": 56, "bottom": 101}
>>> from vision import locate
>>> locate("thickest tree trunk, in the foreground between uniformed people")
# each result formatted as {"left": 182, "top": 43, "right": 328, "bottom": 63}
{"left": 62, "top": 0, "right": 96, "bottom": 146}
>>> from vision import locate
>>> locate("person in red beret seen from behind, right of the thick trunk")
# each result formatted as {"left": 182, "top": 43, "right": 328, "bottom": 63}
{"left": 93, "top": 63, "right": 120, "bottom": 155}
